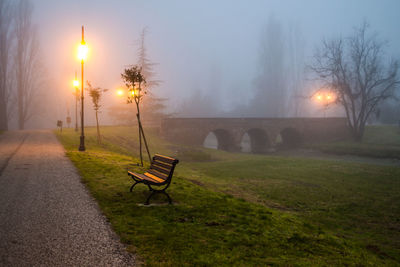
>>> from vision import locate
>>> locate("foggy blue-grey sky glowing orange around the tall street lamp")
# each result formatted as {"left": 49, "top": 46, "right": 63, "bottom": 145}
{"left": 2, "top": 0, "right": 400, "bottom": 128}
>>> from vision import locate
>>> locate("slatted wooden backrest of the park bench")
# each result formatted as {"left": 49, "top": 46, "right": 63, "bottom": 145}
{"left": 147, "top": 154, "right": 179, "bottom": 182}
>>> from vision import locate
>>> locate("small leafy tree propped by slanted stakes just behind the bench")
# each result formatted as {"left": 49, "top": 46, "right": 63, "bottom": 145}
{"left": 121, "top": 66, "right": 151, "bottom": 166}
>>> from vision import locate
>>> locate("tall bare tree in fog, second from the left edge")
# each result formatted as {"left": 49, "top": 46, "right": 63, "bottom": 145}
{"left": 14, "top": 0, "right": 43, "bottom": 129}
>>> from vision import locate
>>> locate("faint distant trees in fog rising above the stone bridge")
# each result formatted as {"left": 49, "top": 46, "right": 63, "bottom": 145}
{"left": 177, "top": 16, "right": 305, "bottom": 117}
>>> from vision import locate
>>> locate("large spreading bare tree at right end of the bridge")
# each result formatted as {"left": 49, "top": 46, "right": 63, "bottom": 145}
{"left": 310, "top": 23, "right": 400, "bottom": 141}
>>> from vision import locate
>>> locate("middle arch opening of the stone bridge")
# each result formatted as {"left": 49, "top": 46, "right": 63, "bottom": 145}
{"left": 240, "top": 128, "right": 271, "bottom": 153}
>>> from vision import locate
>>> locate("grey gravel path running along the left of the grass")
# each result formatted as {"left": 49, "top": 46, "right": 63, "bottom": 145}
{"left": 0, "top": 131, "right": 135, "bottom": 266}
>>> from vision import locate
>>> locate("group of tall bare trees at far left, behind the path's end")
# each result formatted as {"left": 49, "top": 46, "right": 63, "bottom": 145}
{"left": 0, "top": 0, "right": 45, "bottom": 130}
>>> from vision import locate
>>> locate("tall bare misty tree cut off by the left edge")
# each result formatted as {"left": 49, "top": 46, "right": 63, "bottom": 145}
{"left": 0, "top": 0, "right": 13, "bottom": 130}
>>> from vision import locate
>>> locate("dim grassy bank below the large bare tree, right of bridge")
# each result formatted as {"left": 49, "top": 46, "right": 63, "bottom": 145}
{"left": 310, "top": 125, "right": 400, "bottom": 159}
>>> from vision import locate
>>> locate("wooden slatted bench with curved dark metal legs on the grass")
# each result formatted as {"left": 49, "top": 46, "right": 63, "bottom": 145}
{"left": 128, "top": 154, "right": 179, "bottom": 205}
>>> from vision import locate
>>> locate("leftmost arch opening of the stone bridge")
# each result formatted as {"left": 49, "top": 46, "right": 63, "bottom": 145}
{"left": 203, "top": 129, "right": 235, "bottom": 151}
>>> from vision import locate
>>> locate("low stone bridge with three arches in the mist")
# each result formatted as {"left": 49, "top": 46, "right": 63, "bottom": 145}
{"left": 161, "top": 118, "right": 349, "bottom": 153}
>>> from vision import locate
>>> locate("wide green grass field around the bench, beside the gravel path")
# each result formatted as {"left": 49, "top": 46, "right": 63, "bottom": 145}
{"left": 57, "top": 127, "right": 400, "bottom": 266}
